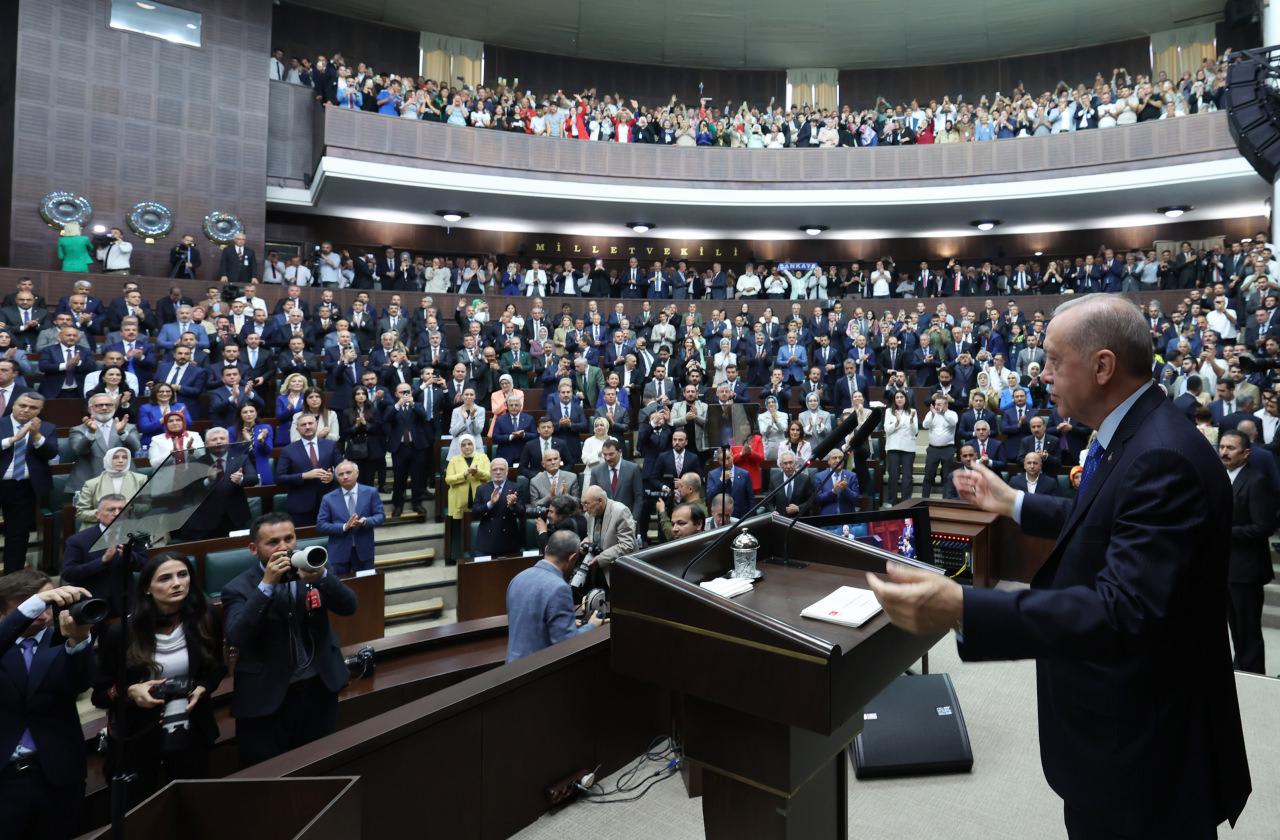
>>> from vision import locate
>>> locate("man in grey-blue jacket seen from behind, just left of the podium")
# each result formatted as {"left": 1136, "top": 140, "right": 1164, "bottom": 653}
{"left": 507, "top": 532, "right": 604, "bottom": 662}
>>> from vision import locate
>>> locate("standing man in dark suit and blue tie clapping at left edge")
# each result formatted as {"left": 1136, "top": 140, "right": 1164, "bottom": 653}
{"left": 0, "top": 391, "right": 58, "bottom": 575}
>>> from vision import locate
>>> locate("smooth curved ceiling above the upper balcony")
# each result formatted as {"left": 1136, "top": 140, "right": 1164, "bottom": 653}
{"left": 294, "top": 0, "right": 1222, "bottom": 69}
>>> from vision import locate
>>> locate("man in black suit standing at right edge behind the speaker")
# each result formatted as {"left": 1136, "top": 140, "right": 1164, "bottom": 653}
{"left": 1217, "top": 429, "right": 1277, "bottom": 674}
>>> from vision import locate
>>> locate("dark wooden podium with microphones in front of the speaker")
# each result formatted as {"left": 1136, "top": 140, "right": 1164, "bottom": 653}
{"left": 609, "top": 513, "right": 941, "bottom": 840}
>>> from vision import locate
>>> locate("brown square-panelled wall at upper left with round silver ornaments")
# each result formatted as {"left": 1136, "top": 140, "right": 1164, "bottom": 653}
{"left": 10, "top": 0, "right": 271, "bottom": 275}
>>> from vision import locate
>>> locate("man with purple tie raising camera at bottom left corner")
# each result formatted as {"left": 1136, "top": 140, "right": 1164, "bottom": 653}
{"left": 0, "top": 569, "right": 93, "bottom": 840}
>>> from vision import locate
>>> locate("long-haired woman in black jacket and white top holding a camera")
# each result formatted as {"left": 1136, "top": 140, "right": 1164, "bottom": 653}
{"left": 93, "top": 552, "right": 227, "bottom": 805}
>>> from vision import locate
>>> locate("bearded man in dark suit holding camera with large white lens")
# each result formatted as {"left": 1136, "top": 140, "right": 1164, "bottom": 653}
{"left": 223, "top": 513, "right": 356, "bottom": 767}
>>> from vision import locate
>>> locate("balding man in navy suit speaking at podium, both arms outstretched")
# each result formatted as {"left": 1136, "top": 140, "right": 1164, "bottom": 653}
{"left": 868, "top": 295, "right": 1252, "bottom": 840}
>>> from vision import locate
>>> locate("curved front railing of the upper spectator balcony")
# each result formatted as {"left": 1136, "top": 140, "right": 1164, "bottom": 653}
{"left": 268, "top": 83, "right": 1238, "bottom": 190}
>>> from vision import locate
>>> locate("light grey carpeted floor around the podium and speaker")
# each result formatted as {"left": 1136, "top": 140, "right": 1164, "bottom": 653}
{"left": 516, "top": 630, "right": 1280, "bottom": 840}
